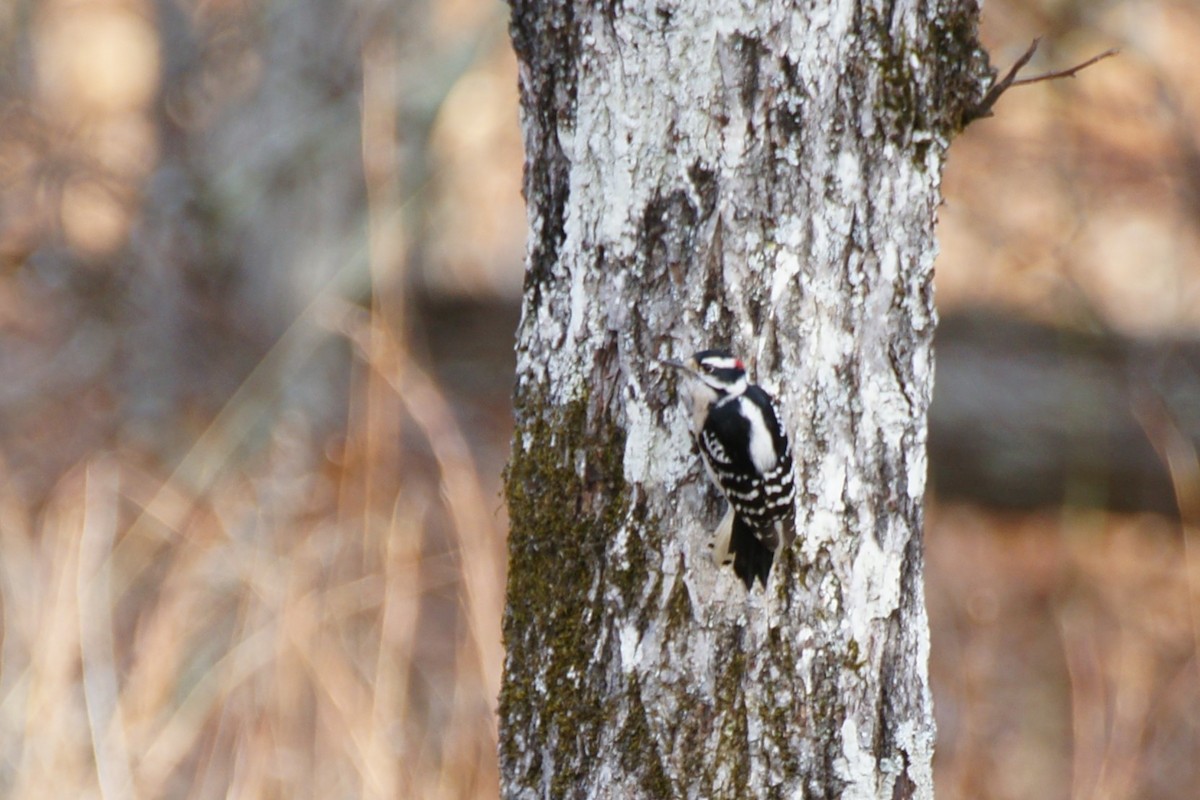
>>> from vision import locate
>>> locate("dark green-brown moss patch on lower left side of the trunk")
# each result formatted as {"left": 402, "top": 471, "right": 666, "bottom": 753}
{"left": 500, "top": 390, "right": 629, "bottom": 798}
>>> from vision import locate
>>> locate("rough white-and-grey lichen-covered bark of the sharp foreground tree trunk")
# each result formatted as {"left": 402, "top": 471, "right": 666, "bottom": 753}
{"left": 500, "top": 0, "right": 988, "bottom": 799}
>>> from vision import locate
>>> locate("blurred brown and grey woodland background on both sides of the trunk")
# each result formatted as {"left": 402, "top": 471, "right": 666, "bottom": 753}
{"left": 0, "top": 0, "right": 1200, "bottom": 799}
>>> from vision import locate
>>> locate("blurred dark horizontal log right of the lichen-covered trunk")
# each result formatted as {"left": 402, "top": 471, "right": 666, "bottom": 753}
{"left": 929, "top": 309, "right": 1200, "bottom": 517}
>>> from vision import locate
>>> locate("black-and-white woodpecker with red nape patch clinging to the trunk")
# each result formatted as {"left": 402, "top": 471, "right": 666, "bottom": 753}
{"left": 662, "top": 350, "right": 796, "bottom": 590}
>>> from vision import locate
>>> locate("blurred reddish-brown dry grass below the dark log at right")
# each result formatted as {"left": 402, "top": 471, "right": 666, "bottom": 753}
{"left": 926, "top": 507, "right": 1200, "bottom": 800}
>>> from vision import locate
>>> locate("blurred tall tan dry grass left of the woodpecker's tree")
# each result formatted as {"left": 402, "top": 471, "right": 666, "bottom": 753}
{"left": 0, "top": 316, "right": 504, "bottom": 799}
